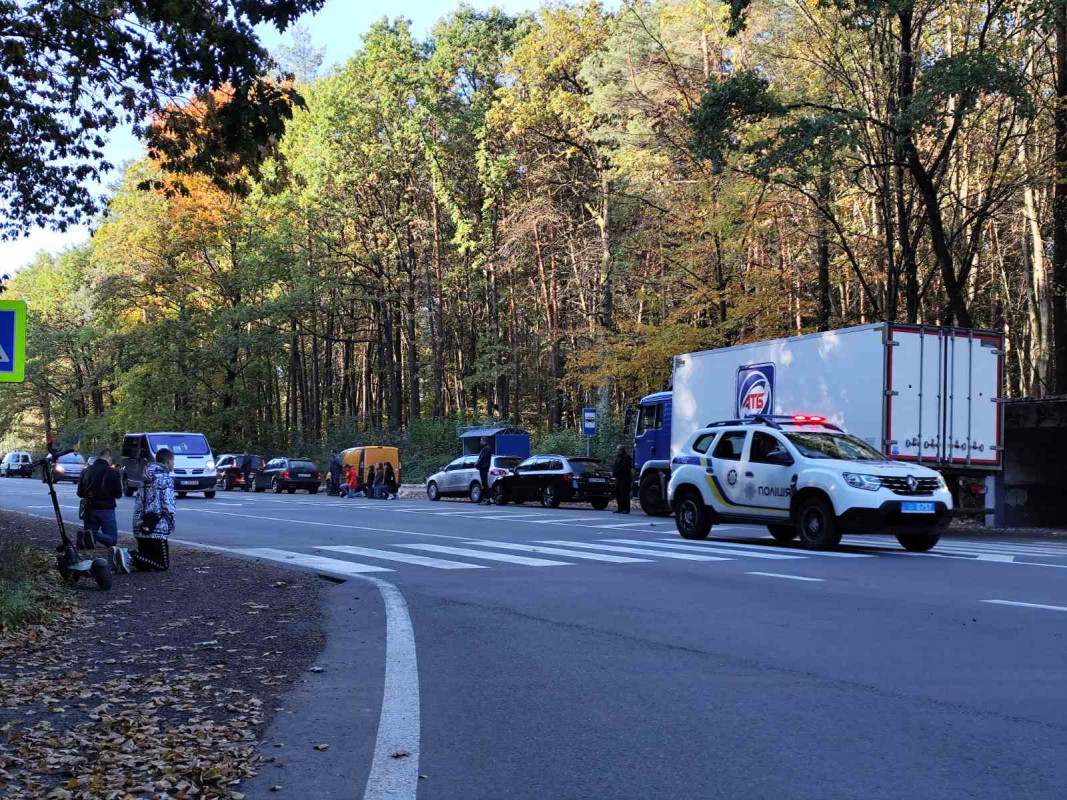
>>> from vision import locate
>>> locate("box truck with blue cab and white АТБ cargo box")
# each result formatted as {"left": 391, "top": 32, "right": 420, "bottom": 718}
{"left": 634, "top": 322, "right": 1004, "bottom": 515}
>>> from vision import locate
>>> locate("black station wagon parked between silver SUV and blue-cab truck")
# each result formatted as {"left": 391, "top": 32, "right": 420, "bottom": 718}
{"left": 493, "top": 455, "right": 615, "bottom": 511}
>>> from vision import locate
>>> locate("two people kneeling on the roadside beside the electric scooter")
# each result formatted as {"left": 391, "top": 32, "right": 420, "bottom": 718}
{"left": 77, "top": 448, "right": 177, "bottom": 575}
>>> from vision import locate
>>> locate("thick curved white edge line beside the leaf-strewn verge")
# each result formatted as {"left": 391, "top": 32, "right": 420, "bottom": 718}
{"left": 363, "top": 577, "right": 419, "bottom": 800}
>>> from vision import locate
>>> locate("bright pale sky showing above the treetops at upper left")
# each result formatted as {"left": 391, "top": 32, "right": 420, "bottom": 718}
{"left": 0, "top": 0, "right": 541, "bottom": 274}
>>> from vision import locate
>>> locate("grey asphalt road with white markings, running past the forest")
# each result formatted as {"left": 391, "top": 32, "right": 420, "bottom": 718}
{"left": 0, "top": 479, "right": 1067, "bottom": 800}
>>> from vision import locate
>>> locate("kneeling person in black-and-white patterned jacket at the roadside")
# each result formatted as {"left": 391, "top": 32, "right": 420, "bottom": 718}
{"left": 112, "top": 447, "right": 175, "bottom": 575}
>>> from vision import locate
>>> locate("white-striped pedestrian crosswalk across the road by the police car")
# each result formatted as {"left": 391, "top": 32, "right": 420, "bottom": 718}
{"left": 223, "top": 534, "right": 1067, "bottom": 577}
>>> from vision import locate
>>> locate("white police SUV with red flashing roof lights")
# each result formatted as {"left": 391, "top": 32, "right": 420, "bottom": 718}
{"left": 667, "top": 415, "right": 952, "bottom": 551}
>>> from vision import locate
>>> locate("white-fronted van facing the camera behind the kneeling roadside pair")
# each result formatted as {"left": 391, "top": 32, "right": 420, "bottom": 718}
{"left": 121, "top": 431, "right": 216, "bottom": 499}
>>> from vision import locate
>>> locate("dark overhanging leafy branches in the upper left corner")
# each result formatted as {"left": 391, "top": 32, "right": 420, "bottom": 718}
{"left": 0, "top": 0, "right": 322, "bottom": 238}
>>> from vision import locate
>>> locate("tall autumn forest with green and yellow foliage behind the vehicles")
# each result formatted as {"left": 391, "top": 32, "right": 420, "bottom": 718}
{"left": 0, "top": 0, "right": 1067, "bottom": 477}
